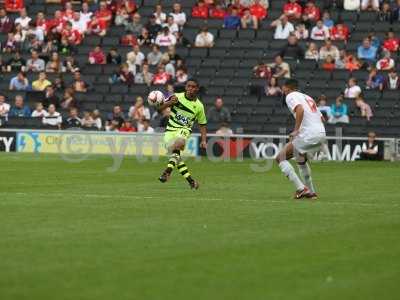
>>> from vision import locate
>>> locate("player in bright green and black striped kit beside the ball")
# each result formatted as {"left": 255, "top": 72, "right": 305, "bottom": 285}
{"left": 159, "top": 79, "right": 207, "bottom": 189}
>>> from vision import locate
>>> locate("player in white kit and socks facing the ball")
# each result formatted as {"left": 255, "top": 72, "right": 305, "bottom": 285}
{"left": 276, "top": 79, "right": 326, "bottom": 199}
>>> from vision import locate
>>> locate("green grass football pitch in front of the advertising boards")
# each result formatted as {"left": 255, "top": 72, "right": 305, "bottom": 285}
{"left": 0, "top": 154, "right": 400, "bottom": 300}
